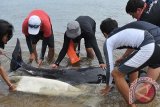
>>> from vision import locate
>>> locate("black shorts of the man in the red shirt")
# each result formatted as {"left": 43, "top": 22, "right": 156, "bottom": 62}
{"left": 30, "top": 32, "right": 54, "bottom": 48}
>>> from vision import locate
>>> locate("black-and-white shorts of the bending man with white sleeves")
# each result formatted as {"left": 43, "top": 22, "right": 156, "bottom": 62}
{"left": 118, "top": 44, "right": 160, "bottom": 74}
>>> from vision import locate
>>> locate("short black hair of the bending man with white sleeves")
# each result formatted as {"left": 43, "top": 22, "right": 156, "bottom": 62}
{"left": 100, "top": 18, "right": 118, "bottom": 34}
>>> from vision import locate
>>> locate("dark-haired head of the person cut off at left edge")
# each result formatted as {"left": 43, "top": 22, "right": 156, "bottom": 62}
{"left": 0, "top": 19, "right": 14, "bottom": 45}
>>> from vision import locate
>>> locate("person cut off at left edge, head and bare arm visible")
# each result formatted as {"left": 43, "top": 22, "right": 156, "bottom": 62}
{"left": 0, "top": 19, "right": 16, "bottom": 91}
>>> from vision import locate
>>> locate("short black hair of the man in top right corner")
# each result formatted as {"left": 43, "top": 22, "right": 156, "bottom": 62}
{"left": 126, "top": 0, "right": 145, "bottom": 13}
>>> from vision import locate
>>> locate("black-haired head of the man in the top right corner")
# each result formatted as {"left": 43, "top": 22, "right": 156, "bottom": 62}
{"left": 126, "top": 0, "right": 145, "bottom": 19}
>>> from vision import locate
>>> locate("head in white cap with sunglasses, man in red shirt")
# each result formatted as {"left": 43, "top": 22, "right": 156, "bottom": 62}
{"left": 28, "top": 15, "right": 41, "bottom": 35}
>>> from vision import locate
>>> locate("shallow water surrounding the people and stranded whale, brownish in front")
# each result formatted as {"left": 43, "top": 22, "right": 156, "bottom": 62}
{"left": 0, "top": 0, "right": 160, "bottom": 107}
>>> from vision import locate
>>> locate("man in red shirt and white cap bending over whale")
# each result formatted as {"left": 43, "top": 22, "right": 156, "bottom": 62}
{"left": 22, "top": 10, "right": 54, "bottom": 66}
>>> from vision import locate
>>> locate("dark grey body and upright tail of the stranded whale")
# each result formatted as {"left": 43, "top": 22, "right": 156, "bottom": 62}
{"left": 10, "top": 39, "right": 106, "bottom": 84}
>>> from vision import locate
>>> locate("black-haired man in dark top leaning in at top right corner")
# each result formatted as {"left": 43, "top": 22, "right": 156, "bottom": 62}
{"left": 126, "top": 0, "right": 160, "bottom": 26}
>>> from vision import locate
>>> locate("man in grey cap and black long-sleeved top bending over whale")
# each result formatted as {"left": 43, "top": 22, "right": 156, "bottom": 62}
{"left": 52, "top": 16, "right": 106, "bottom": 68}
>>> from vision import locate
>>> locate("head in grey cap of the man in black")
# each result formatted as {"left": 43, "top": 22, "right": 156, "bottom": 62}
{"left": 66, "top": 21, "right": 81, "bottom": 39}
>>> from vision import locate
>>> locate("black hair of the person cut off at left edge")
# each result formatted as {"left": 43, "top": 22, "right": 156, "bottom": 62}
{"left": 0, "top": 19, "right": 14, "bottom": 41}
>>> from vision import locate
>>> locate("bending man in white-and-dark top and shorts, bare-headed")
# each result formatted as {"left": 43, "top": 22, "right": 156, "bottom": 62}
{"left": 100, "top": 18, "right": 160, "bottom": 107}
